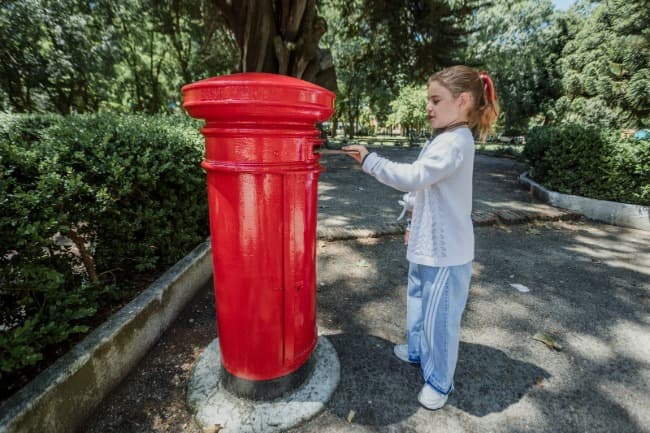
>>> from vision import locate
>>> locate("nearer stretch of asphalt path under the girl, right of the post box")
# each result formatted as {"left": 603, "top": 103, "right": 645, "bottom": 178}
{"left": 319, "top": 223, "right": 650, "bottom": 432}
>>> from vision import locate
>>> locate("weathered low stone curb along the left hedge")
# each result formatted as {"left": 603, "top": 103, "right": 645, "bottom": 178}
{"left": 0, "top": 240, "right": 212, "bottom": 433}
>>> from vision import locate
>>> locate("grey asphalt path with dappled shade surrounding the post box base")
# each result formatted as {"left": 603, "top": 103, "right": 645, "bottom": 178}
{"left": 81, "top": 150, "right": 650, "bottom": 433}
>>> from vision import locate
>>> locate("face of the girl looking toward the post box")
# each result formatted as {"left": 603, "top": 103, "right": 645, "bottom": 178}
{"left": 427, "top": 81, "right": 470, "bottom": 129}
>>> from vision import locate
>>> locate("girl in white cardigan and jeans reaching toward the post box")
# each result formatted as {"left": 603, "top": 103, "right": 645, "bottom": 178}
{"left": 343, "top": 66, "right": 498, "bottom": 410}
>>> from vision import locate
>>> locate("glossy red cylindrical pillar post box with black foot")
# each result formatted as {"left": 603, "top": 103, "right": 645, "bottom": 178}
{"left": 182, "top": 73, "right": 334, "bottom": 398}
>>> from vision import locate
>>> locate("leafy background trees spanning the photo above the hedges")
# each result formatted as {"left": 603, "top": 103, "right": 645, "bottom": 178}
{"left": 0, "top": 0, "right": 650, "bottom": 135}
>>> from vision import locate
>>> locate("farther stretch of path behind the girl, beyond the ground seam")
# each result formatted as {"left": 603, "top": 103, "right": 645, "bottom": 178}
{"left": 318, "top": 148, "right": 578, "bottom": 239}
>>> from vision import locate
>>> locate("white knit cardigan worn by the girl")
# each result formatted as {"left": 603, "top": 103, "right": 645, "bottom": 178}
{"left": 362, "top": 127, "right": 474, "bottom": 266}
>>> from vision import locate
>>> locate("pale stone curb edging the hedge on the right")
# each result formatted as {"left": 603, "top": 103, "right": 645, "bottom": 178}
{"left": 519, "top": 172, "right": 650, "bottom": 231}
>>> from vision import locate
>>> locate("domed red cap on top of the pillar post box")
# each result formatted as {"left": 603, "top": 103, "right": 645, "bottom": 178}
{"left": 182, "top": 72, "right": 335, "bottom": 122}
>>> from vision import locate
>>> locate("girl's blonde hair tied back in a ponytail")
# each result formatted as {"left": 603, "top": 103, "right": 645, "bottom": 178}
{"left": 428, "top": 65, "right": 499, "bottom": 140}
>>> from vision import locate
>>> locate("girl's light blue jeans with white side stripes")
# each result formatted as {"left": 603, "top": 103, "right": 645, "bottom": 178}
{"left": 406, "top": 262, "right": 472, "bottom": 395}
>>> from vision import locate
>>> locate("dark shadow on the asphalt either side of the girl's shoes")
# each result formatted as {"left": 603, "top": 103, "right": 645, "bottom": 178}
{"left": 328, "top": 334, "right": 550, "bottom": 425}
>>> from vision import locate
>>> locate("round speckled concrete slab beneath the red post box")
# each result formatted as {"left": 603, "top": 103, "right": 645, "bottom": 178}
{"left": 187, "top": 336, "right": 341, "bottom": 433}
